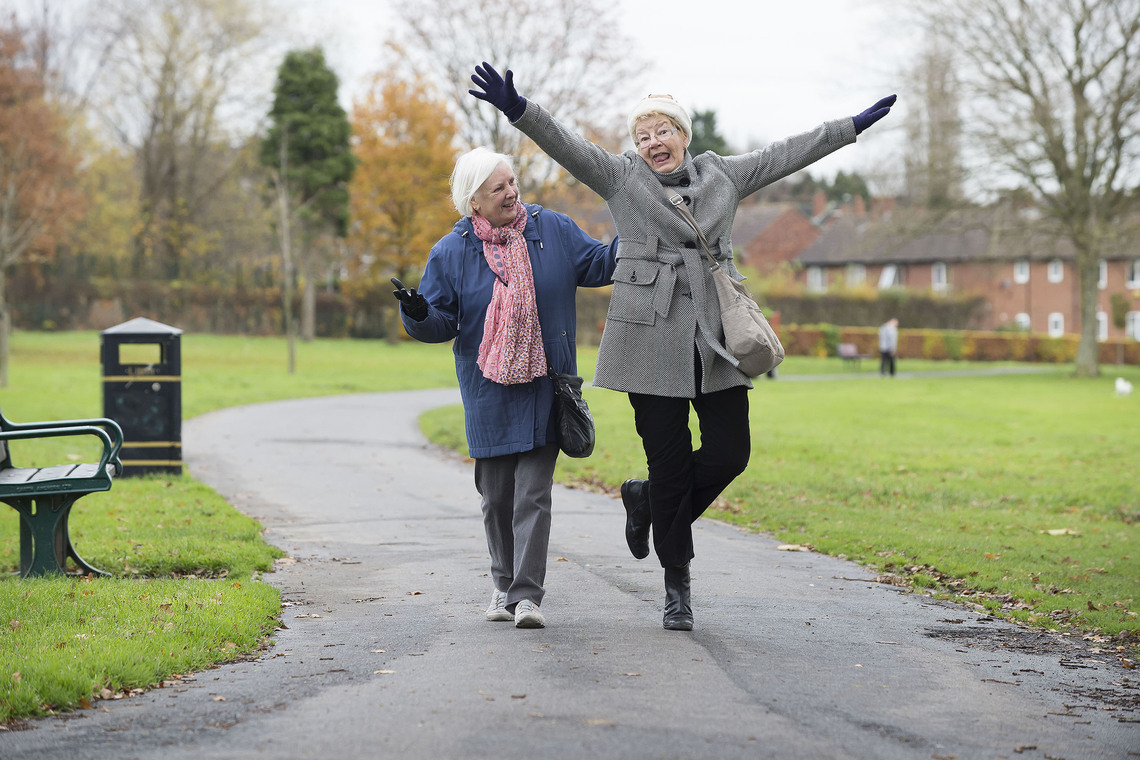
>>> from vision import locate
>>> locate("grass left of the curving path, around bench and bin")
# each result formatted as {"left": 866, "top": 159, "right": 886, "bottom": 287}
{"left": 0, "top": 333, "right": 455, "bottom": 729}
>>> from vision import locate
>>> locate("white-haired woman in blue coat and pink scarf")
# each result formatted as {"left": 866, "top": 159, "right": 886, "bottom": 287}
{"left": 393, "top": 148, "right": 617, "bottom": 628}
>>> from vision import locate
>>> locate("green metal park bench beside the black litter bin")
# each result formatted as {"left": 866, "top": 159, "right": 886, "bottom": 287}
{"left": 0, "top": 414, "right": 123, "bottom": 578}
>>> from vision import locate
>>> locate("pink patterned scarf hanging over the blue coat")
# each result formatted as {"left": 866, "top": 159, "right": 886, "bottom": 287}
{"left": 471, "top": 203, "right": 546, "bottom": 385}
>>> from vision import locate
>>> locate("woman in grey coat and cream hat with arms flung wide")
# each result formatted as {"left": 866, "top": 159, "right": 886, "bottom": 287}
{"left": 469, "top": 63, "right": 895, "bottom": 630}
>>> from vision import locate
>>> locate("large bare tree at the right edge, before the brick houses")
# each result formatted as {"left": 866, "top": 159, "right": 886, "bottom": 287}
{"left": 920, "top": 0, "right": 1140, "bottom": 377}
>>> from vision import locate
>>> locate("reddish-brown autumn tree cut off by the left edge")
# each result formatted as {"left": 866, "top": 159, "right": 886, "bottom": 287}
{"left": 0, "top": 24, "right": 82, "bottom": 386}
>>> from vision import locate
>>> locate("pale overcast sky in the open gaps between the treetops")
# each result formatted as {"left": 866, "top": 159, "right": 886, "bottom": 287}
{"left": 276, "top": 0, "right": 914, "bottom": 181}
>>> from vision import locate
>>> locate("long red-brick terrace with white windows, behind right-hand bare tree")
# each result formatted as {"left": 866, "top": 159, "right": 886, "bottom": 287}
{"left": 796, "top": 206, "right": 1140, "bottom": 340}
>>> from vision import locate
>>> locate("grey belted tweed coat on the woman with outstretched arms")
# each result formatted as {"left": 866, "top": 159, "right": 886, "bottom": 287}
{"left": 514, "top": 100, "right": 855, "bottom": 399}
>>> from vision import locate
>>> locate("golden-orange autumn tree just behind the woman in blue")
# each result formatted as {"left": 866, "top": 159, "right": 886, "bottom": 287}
{"left": 344, "top": 71, "right": 456, "bottom": 340}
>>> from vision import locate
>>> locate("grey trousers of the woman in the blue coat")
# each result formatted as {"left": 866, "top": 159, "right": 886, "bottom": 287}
{"left": 475, "top": 443, "right": 559, "bottom": 611}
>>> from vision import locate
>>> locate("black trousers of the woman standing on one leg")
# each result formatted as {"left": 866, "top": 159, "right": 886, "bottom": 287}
{"left": 629, "top": 387, "right": 752, "bottom": 567}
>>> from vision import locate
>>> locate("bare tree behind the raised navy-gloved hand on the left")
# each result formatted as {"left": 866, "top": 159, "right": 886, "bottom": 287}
{"left": 389, "top": 0, "right": 645, "bottom": 191}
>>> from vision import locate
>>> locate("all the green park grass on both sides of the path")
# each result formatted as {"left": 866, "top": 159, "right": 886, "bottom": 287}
{"left": 0, "top": 333, "right": 1140, "bottom": 721}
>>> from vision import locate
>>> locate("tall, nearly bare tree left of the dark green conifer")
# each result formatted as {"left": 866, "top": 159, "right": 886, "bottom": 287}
{"left": 90, "top": 0, "right": 273, "bottom": 278}
